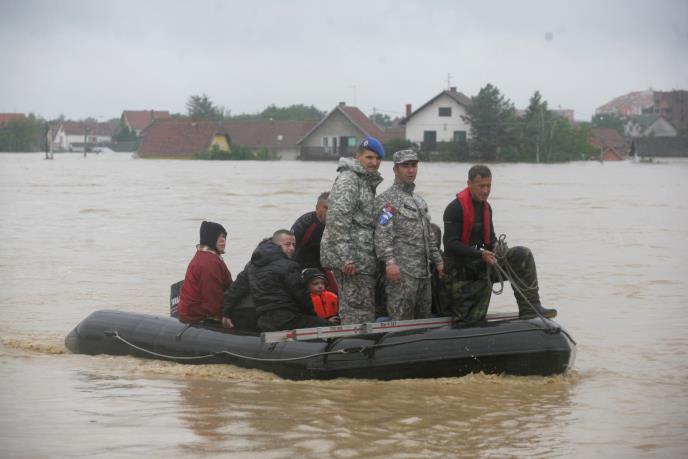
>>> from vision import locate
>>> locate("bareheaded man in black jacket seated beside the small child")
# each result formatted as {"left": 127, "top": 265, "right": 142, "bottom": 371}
{"left": 222, "top": 229, "right": 330, "bottom": 331}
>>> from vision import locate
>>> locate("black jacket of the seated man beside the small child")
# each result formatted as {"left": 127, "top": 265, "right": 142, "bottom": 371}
{"left": 224, "top": 239, "right": 315, "bottom": 317}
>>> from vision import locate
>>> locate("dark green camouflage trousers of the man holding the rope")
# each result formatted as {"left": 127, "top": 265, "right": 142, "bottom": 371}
{"left": 438, "top": 247, "right": 540, "bottom": 323}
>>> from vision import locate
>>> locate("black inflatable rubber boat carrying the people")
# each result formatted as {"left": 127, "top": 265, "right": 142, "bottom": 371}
{"left": 65, "top": 310, "right": 576, "bottom": 380}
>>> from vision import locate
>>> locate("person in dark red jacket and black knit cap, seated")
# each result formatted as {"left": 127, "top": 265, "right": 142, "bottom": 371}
{"left": 179, "top": 221, "right": 232, "bottom": 323}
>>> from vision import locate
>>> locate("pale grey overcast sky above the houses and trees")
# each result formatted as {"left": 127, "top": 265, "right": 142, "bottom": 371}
{"left": 0, "top": 0, "right": 688, "bottom": 120}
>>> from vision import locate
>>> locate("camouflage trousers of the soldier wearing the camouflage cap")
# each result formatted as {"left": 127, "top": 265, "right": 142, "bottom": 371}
{"left": 385, "top": 273, "right": 432, "bottom": 320}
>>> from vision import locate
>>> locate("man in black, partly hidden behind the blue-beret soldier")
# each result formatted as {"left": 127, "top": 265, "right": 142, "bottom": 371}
{"left": 291, "top": 191, "right": 330, "bottom": 269}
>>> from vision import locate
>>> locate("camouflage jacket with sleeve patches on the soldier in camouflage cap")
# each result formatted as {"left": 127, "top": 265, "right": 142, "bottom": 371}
{"left": 375, "top": 182, "right": 442, "bottom": 278}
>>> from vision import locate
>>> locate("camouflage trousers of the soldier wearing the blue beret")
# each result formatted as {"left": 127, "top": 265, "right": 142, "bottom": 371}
{"left": 332, "top": 269, "right": 375, "bottom": 324}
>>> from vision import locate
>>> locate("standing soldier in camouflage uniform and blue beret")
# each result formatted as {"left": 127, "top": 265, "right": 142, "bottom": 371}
{"left": 320, "top": 137, "right": 385, "bottom": 324}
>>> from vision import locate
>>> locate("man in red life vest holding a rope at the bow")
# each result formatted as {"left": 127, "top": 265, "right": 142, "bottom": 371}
{"left": 443, "top": 165, "right": 557, "bottom": 322}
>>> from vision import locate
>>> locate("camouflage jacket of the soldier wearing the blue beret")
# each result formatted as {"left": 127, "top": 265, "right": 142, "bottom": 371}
{"left": 320, "top": 158, "right": 382, "bottom": 275}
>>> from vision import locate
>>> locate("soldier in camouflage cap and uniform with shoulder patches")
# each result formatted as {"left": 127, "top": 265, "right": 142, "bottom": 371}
{"left": 375, "top": 150, "right": 444, "bottom": 320}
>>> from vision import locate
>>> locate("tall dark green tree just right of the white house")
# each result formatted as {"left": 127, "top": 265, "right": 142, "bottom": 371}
{"left": 462, "top": 83, "right": 518, "bottom": 161}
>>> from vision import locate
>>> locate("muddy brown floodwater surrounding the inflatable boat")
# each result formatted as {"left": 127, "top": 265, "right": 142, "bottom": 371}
{"left": 0, "top": 153, "right": 688, "bottom": 459}
